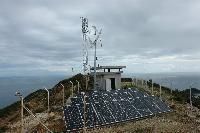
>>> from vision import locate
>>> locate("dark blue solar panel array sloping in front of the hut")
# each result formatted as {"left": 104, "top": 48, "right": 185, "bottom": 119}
{"left": 64, "top": 88, "right": 171, "bottom": 131}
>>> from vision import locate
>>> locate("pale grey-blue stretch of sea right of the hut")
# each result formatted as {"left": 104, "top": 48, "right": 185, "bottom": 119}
{"left": 124, "top": 72, "right": 200, "bottom": 90}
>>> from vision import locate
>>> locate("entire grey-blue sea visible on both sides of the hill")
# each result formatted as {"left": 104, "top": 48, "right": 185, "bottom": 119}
{"left": 0, "top": 73, "right": 200, "bottom": 108}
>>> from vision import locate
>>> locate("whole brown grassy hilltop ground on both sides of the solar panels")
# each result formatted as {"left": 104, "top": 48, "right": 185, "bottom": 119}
{"left": 0, "top": 74, "right": 200, "bottom": 132}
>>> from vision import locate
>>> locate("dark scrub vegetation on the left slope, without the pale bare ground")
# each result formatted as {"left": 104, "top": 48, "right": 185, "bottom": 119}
{"left": 0, "top": 74, "right": 93, "bottom": 132}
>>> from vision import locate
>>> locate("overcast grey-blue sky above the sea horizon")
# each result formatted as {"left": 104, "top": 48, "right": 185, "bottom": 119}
{"left": 0, "top": 0, "right": 200, "bottom": 76}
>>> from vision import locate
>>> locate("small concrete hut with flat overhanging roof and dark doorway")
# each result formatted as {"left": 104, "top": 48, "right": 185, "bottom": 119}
{"left": 91, "top": 66, "right": 126, "bottom": 90}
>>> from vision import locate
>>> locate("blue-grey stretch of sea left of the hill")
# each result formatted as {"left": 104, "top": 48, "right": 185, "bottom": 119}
{"left": 0, "top": 75, "right": 67, "bottom": 108}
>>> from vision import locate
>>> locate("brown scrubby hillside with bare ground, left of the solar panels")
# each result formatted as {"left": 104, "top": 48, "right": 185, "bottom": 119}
{"left": 0, "top": 74, "right": 92, "bottom": 132}
